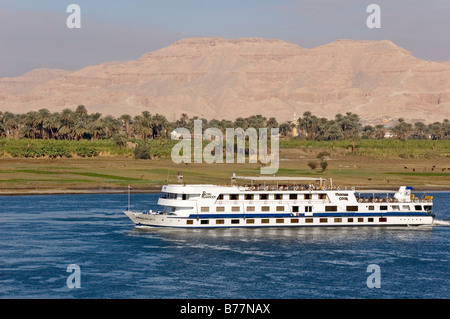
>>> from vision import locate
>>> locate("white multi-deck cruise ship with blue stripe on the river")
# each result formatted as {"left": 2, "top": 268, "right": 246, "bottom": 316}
{"left": 124, "top": 174, "right": 434, "bottom": 228}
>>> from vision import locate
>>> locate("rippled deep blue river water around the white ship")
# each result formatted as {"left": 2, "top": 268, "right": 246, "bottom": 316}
{"left": 0, "top": 192, "right": 450, "bottom": 299}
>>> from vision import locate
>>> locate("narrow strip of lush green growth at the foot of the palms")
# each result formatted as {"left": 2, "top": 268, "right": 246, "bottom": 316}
{"left": 0, "top": 139, "right": 450, "bottom": 159}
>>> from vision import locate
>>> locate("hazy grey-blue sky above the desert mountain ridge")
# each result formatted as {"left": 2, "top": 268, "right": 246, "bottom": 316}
{"left": 0, "top": 0, "right": 450, "bottom": 78}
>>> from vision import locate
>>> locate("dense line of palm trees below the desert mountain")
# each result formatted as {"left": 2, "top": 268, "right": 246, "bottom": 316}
{"left": 0, "top": 105, "right": 450, "bottom": 143}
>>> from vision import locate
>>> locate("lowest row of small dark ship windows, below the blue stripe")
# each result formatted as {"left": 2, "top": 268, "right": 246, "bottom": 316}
{"left": 186, "top": 217, "right": 387, "bottom": 225}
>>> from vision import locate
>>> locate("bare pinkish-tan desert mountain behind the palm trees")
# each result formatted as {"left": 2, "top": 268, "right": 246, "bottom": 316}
{"left": 0, "top": 38, "right": 450, "bottom": 122}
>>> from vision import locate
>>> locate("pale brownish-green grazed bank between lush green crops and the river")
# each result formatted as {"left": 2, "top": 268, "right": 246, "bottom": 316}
{"left": 0, "top": 149, "right": 450, "bottom": 195}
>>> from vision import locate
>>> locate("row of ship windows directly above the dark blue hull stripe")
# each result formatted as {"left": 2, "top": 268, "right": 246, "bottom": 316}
{"left": 200, "top": 205, "right": 428, "bottom": 213}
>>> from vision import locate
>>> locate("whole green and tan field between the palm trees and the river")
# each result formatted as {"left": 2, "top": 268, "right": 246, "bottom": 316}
{"left": 0, "top": 139, "right": 450, "bottom": 194}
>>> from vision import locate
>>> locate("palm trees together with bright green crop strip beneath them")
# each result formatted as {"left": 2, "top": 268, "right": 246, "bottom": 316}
{"left": 0, "top": 105, "right": 450, "bottom": 158}
